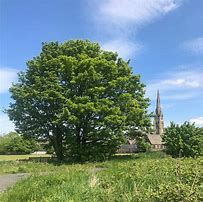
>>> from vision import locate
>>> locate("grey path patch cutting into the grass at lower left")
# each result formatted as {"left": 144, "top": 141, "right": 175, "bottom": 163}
{"left": 0, "top": 173, "right": 29, "bottom": 192}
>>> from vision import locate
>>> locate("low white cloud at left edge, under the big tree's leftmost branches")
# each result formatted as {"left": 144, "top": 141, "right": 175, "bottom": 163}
{"left": 0, "top": 114, "right": 15, "bottom": 135}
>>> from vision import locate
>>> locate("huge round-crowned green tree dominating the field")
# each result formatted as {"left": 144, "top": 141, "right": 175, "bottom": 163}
{"left": 7, "top": 40, "right": 149, "bottom": 160}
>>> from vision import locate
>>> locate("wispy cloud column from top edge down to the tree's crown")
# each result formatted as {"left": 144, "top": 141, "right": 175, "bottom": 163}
{"left": 91, "top": 0, "right": 183, "bottom": 58}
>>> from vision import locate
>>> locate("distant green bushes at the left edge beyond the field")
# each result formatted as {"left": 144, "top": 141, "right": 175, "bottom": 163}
{"left": 0, "top": 132, "right": 38, "bottom": 154}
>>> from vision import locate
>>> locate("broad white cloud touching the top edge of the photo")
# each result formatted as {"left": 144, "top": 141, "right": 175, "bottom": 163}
{"left": 99, "top": 0, "right": 182, "bottom": 26}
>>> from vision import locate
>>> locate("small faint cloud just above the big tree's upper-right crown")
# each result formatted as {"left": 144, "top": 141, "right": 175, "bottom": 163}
{"left": 102, "top": 39, "right": 142, "bottom": 59}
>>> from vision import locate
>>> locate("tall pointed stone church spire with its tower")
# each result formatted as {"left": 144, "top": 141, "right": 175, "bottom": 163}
{"left": 154, "top": 90, "right": 164, "bottom": 135}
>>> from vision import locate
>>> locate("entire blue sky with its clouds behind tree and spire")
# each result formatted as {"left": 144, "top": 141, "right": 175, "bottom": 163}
{"left": 0, "top": 0, "right": 203, "bottom": 134}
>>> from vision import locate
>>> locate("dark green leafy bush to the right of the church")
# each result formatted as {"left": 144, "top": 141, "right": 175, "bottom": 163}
{"left": 163, "top": 122, "right": 203, "bottom": 157}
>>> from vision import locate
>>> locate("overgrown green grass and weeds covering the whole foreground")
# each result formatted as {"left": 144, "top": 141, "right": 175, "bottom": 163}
{"left": 0, "top": 153, "right": 202, "bottom": 202}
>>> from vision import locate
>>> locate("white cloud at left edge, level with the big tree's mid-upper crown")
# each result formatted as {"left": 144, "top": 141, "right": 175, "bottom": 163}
{"left": 0, "top": 68, "right": 17, "bottom": 93}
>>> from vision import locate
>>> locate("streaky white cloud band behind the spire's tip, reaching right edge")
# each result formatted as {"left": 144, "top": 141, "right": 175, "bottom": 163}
{"left": 147, "top": 65, "right": 203, "bottom": 100}
